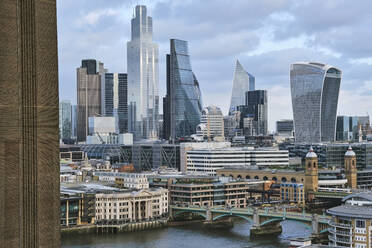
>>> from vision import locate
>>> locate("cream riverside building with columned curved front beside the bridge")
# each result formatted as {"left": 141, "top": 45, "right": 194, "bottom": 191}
{"left": 95, "top": 188, "right": 168, "bottom": 224}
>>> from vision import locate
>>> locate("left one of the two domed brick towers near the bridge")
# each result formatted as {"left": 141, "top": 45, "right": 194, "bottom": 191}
{"left": 305, "top": 147, "right": 318, "bottom": 200}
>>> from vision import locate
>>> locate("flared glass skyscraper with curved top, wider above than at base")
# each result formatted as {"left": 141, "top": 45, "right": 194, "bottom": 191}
{"left": 290, "top": 62, "right": 342, "bottom": 143}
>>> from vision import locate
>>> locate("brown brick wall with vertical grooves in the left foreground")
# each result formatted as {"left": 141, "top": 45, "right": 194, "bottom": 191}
{"left": 0, "top": 0, "right": 60, "bottom": 248}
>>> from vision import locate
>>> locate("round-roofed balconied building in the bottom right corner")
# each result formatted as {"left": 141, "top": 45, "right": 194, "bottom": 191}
{"left": 327, "top": 191, "right": 372, "bottom": 248}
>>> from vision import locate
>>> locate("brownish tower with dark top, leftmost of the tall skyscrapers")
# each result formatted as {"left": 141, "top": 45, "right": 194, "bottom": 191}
{"left": 77, "top": 59, "right": 105, "bottom": 142}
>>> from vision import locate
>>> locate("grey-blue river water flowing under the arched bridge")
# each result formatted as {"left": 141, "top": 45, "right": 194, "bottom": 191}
{"left": 62, "top": 219, "right": 311, "bottom": 248}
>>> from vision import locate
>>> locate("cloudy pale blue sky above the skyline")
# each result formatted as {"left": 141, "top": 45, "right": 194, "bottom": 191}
{"left": 57, "top": 0, "right": 372, "bottom": 130}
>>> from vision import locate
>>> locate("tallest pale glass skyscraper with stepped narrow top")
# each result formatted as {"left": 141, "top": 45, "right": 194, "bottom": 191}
{"left": 127, "top": 5, "right": 159, "bottom": 140}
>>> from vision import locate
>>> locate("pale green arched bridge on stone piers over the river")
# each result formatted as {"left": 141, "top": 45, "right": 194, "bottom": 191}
{"left": 170, "top": 206, "right": 331, "bottom": 235}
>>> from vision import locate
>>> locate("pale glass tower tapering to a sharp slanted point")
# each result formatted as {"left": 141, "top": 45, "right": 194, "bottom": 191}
{"left": 229, "top": 60, "right": 256, "bottom": 115}
